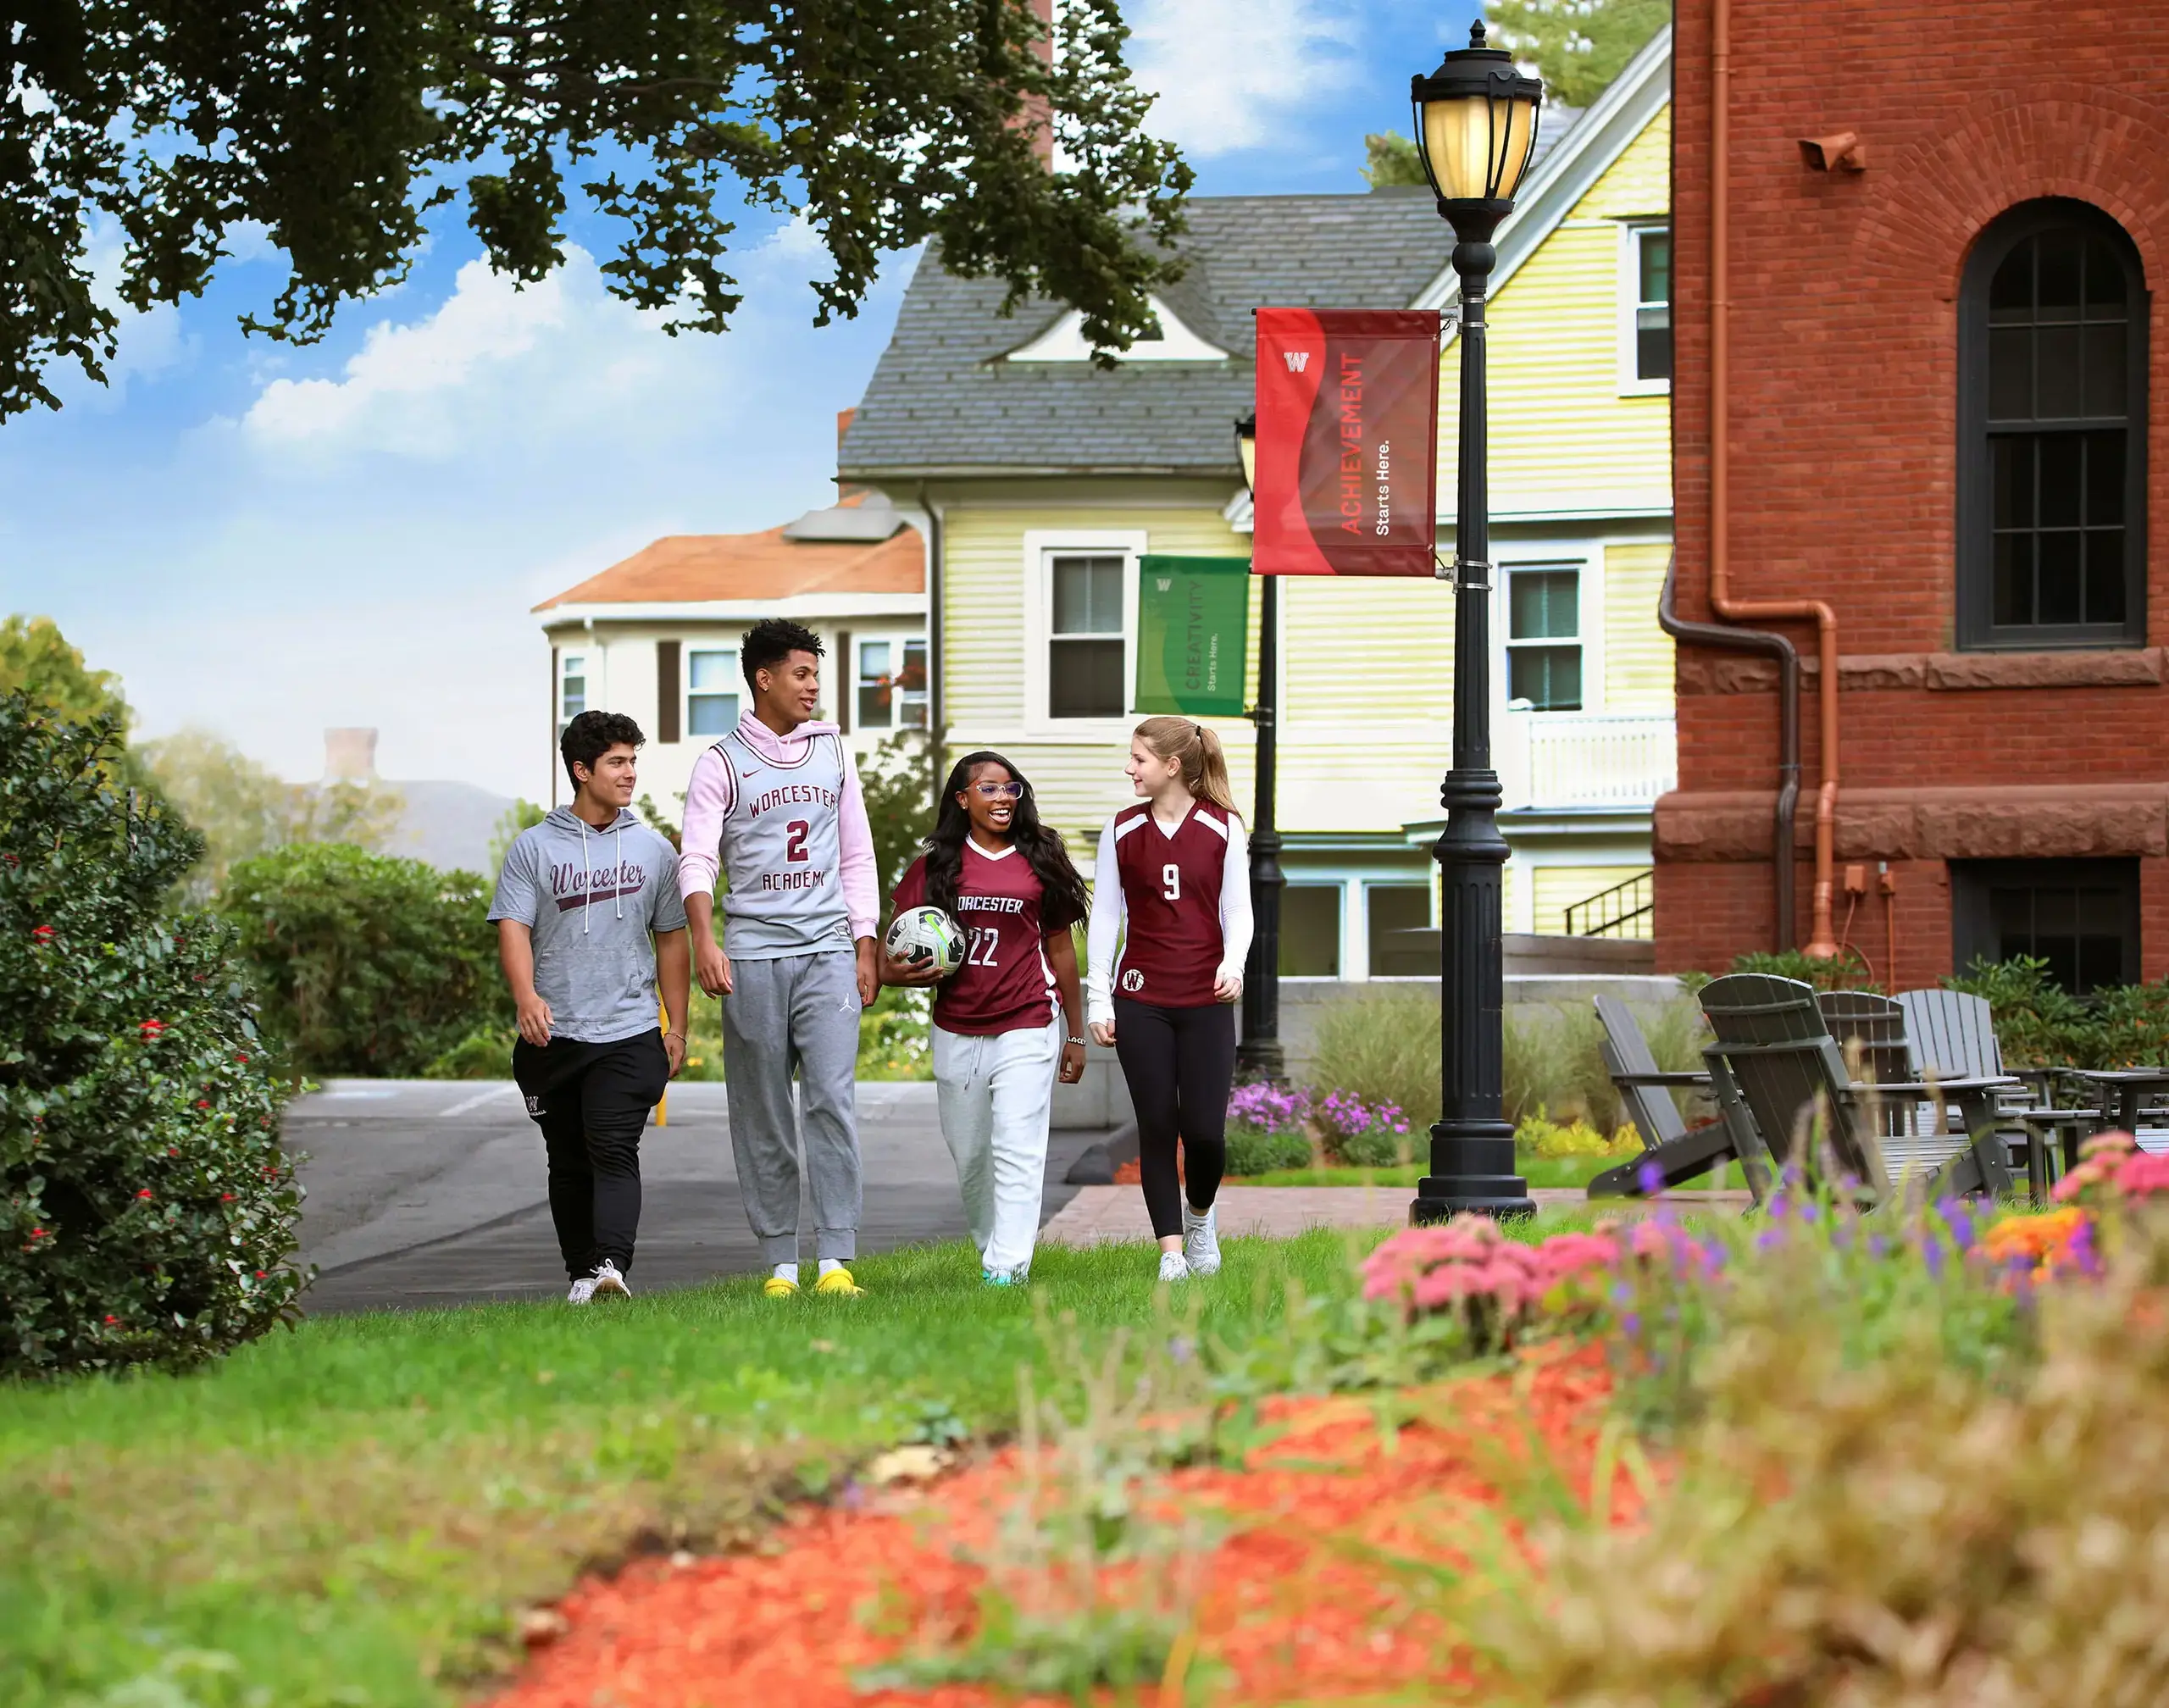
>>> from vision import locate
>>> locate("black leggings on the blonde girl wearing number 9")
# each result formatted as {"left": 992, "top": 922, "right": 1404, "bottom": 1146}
{"left": 1115, "top": 997, "right": 1234, "bottom": 1239}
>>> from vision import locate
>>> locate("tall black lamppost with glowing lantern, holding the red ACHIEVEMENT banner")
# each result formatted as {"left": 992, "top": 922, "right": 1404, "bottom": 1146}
{"left": 1410, "top": 22, "right": 1545, "bottom": 1223}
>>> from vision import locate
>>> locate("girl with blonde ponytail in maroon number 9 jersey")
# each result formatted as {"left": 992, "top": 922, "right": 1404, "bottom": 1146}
{"left": 1087, "top": 718, "right": 1251, "bottom": 1281}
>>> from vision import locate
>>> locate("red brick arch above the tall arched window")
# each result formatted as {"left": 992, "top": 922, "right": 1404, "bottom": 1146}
{"left": 1852, "top": 85, "right": 2169, "bottom": 302}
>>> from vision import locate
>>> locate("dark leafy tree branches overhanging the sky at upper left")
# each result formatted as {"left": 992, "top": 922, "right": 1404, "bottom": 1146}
{"left": 0, "top": 0, "right": 1190, "bottom": 419}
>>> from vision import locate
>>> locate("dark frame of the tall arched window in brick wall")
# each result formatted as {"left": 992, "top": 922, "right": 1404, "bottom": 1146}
{"left": 1956, "top": 197, "right": 2152, "bottom": 652}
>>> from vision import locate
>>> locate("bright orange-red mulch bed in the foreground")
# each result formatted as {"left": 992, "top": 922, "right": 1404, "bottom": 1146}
{"left": 495, "top": 1346, "right": 1639, "bottom": 1708}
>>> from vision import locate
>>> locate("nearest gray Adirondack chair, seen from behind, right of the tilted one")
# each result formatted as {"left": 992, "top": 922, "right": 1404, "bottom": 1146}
{"left": 1703, "top": 973, "right": 2015, "bottom": 1201}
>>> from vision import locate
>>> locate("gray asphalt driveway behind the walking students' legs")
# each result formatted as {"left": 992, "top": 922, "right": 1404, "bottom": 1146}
{"left": 297, "top": 1079, "right": 1110, "bottom": 1313}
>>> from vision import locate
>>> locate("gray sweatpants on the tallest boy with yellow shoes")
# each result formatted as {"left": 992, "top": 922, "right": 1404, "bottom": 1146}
{"left": 722, "top": 951, "right": 863, "bottom": 1264}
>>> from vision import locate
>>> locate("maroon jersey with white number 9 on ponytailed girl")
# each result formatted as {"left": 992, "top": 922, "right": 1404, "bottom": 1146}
{"left": 1115, "top": 800, "right": 1228, "bottom": 1008}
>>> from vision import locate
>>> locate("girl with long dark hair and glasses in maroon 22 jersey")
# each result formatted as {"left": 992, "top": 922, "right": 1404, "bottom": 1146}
{"left": 883, "top": 752, "right": 1091, "bottom": 1288}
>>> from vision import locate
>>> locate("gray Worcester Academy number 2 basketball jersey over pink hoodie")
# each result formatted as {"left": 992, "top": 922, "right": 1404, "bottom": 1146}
{"left": 716, "top": 730, "right": 851, "bottom": 960}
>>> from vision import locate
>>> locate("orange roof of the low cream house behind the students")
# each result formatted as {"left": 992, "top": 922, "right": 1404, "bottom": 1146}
{"left": 535, "top": 527, "right": 926, "bottom": 611}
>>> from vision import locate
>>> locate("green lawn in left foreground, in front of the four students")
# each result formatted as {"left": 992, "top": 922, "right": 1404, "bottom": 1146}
{"left": 0, "top": 1234, "right": 1358, "bottom": 1708}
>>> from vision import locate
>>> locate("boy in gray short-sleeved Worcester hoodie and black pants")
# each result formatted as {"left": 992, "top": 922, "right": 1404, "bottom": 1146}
{"left": 491, "top": 711, "right": 692, "bottom": 1305}
